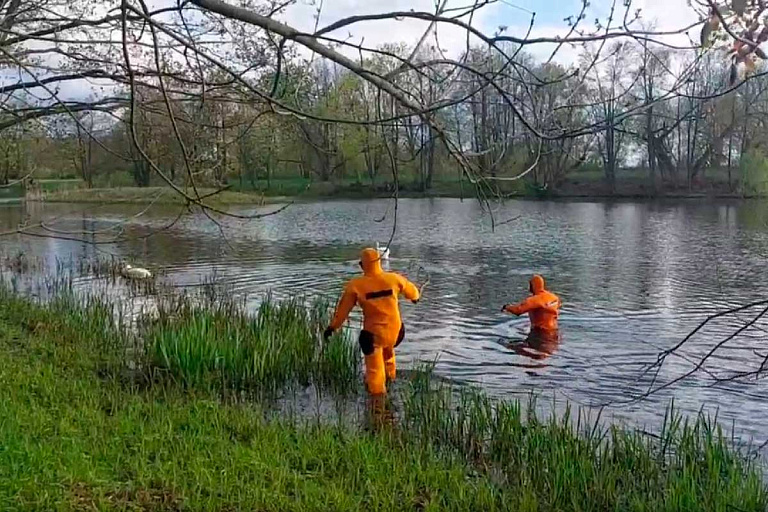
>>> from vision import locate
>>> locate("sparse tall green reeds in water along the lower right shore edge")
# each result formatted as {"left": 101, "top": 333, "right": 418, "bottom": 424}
{"left": 403, "top": 371, "right": 768, "bottom": 511}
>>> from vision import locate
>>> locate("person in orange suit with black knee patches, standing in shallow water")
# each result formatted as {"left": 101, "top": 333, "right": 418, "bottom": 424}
{"left": 323, "top": 249, "right": 421, "bottom": 395}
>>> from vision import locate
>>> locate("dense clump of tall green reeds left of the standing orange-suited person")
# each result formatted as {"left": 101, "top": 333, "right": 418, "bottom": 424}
{"left": 145, "top": 297, "right": 360, "bottom": 394}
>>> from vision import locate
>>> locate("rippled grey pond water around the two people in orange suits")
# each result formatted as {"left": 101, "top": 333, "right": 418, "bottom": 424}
{"left": 0, "top": 199, "right": 768, "bottom": 444}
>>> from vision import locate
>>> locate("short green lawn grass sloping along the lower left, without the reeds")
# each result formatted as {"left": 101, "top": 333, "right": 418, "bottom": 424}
{"left": 0, "top": 290, "right": 503, "bottom": 511}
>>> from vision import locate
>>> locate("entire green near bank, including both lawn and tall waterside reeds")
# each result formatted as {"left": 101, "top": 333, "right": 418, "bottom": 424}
{"left": 0, "top": 282, "right": 768, "bottom": 511}
